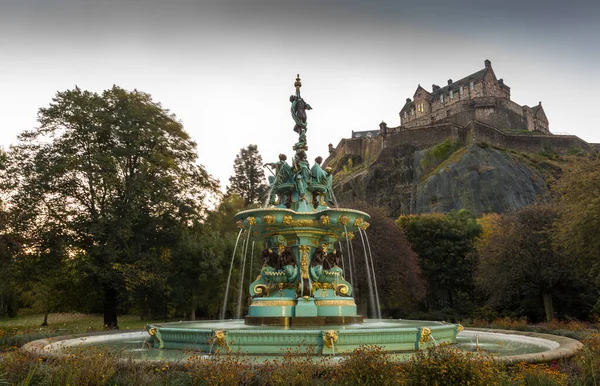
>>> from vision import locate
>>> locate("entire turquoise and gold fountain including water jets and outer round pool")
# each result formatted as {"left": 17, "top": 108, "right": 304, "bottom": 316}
{"left": 24, "top": 77, "right": 581, "bottom": 362}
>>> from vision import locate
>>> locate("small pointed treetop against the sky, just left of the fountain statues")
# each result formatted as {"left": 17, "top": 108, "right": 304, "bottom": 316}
{"left": 227, "top": 145, "right": 268, "bottom": 205}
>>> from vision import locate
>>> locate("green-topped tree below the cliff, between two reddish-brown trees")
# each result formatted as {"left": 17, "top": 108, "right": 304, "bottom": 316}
{"left": 397, "top": 210, "right": 481, "bottom": 313}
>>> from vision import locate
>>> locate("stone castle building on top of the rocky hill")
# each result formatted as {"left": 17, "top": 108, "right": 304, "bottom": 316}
{"left": 395, "top": 60, "right": 550, "bottom": 134}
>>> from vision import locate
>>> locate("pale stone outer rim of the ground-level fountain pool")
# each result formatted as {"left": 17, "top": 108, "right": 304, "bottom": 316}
{"left": 20, "top": 327, "right": 583, "bottom": 365}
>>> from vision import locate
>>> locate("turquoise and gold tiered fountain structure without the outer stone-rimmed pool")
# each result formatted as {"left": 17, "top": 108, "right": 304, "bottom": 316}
{"left": 147, "top": 77, "right": 462, "bottom": 355}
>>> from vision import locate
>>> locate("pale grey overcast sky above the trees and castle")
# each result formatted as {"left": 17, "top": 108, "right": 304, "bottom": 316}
{"left": 0, "top": 0, "right": 600, "bottom": 188}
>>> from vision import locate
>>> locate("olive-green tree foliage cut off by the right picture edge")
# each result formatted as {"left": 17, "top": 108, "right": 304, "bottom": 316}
{"left": 555, "top": 158, "right": 600, "bottom": 286}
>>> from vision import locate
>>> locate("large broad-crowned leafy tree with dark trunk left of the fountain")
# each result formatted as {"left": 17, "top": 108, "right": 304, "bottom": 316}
{"left": 9, "top": 86, "right": 217, "bottom": 328}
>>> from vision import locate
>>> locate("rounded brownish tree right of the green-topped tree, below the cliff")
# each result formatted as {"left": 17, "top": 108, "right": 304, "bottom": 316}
{"left": 477, "top": 204, "right": 584, "bottom": 321}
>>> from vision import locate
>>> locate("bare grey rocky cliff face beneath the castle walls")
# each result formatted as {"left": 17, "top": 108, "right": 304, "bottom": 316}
{"left": 328, "top": 140, "right": 549, "bottom": 217}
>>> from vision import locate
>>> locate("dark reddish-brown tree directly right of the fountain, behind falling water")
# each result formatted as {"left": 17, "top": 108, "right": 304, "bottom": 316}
{"left": 340, "top": 202, "right": 425, "bottom": 317}
